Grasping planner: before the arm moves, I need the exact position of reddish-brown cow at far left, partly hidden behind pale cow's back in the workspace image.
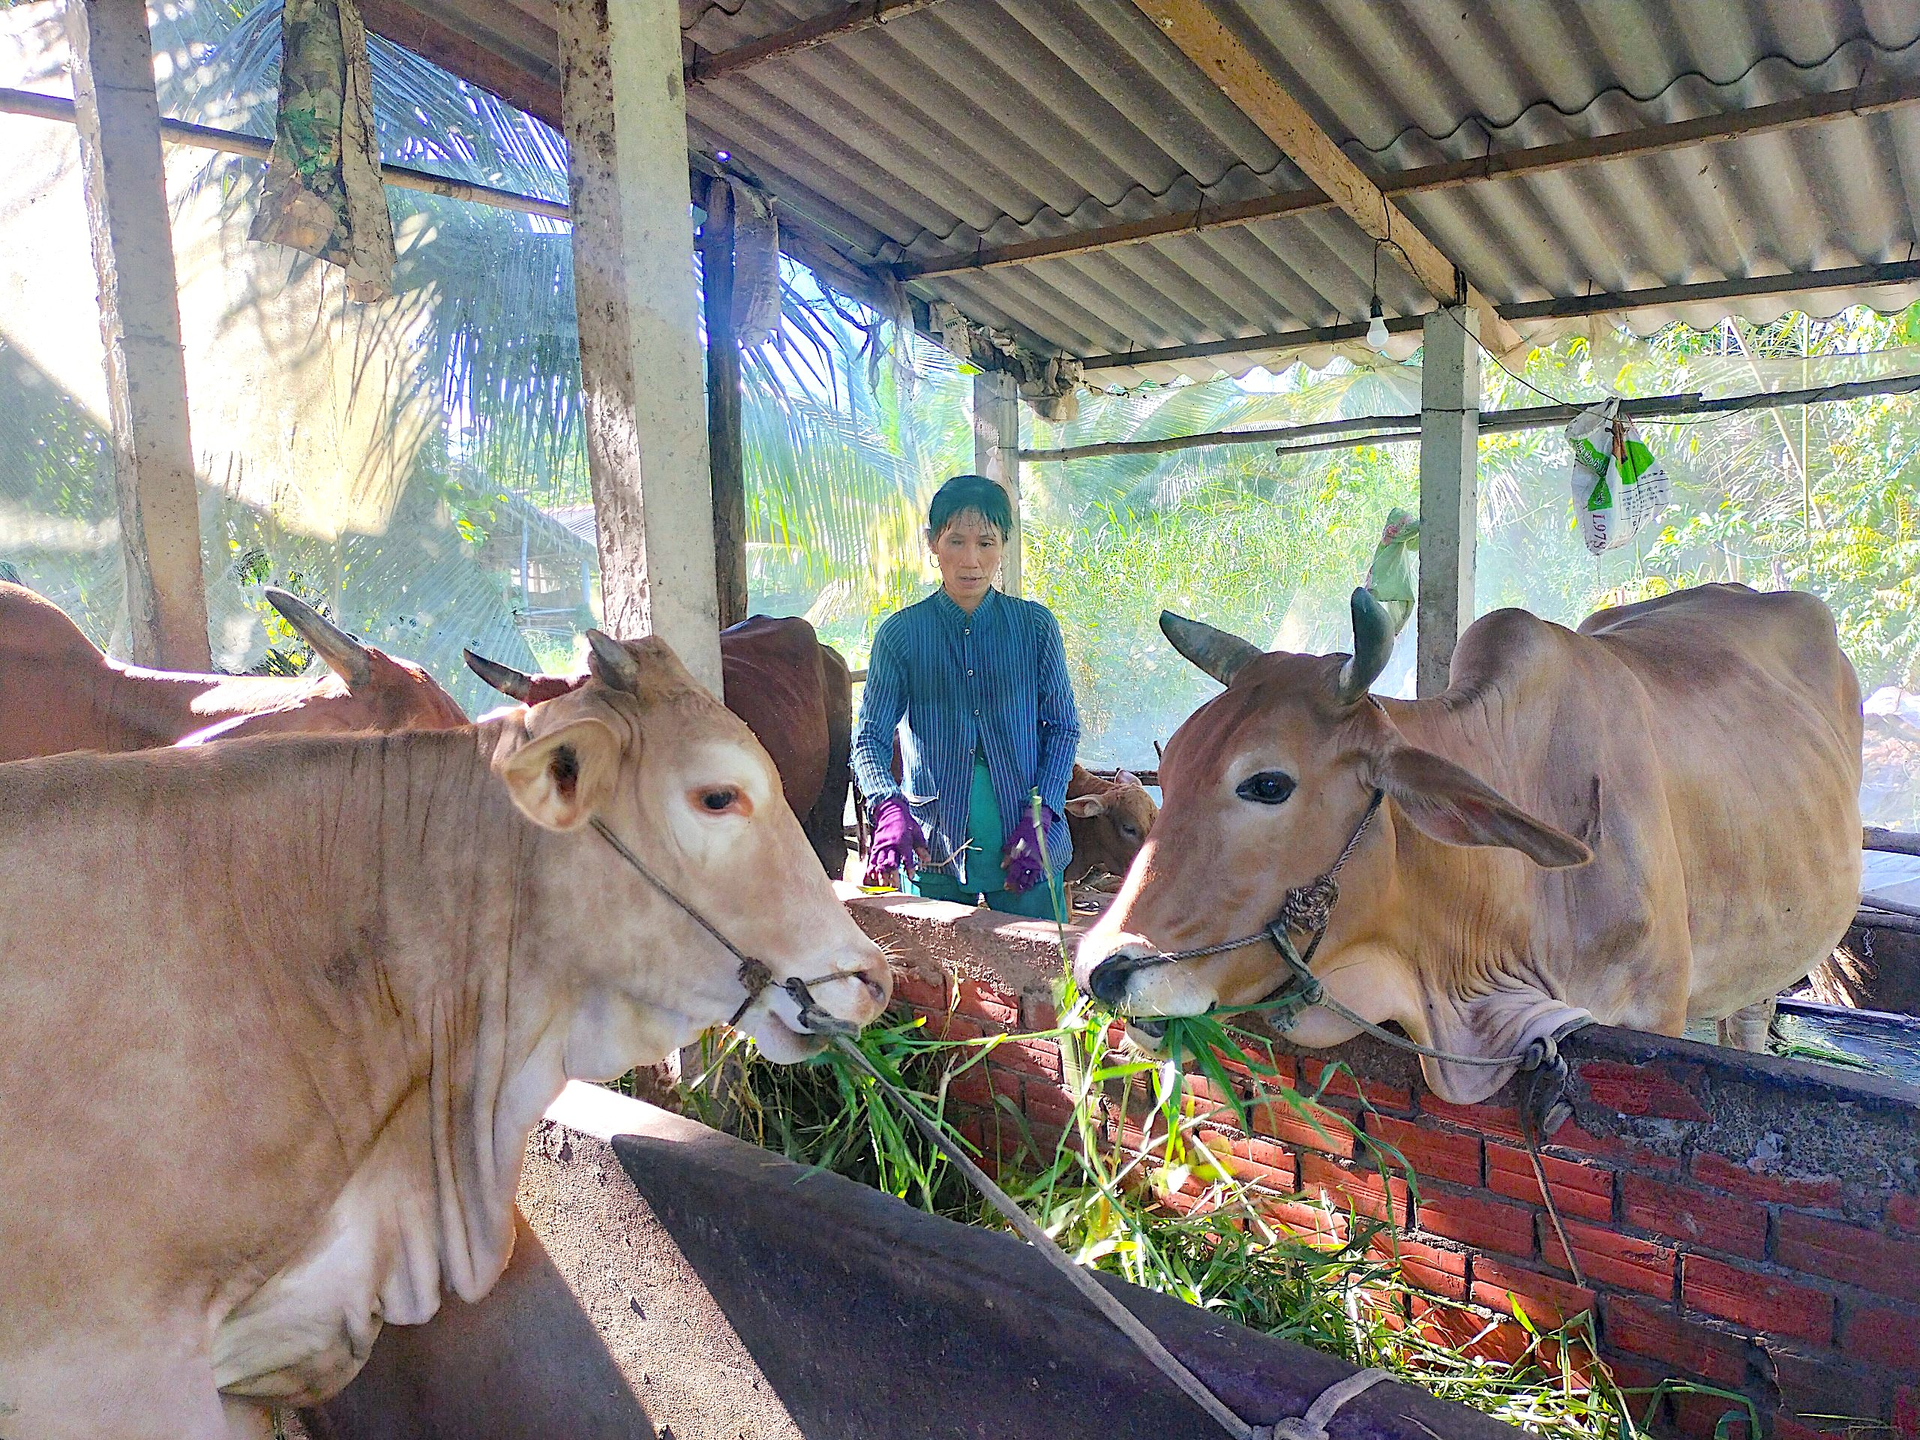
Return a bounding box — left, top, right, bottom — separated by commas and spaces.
0, 584, 467, 760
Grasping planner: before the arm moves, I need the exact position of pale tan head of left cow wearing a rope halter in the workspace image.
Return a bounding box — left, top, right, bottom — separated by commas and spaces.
493, 630, 891, 1079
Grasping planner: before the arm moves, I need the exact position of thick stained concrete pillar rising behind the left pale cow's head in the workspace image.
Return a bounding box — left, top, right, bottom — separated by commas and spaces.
559, 0, 720, 695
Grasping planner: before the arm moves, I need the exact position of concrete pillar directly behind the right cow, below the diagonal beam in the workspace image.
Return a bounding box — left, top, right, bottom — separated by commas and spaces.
1415, 309, 1480, 695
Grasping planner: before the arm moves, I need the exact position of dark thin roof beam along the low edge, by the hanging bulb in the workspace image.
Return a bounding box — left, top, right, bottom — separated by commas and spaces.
1081, 259, 1920, 371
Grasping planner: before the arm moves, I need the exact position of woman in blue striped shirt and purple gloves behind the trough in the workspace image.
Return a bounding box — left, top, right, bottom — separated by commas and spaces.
852, 474, 1079, 918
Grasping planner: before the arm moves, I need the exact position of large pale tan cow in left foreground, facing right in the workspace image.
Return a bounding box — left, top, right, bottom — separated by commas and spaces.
0, 632, 889, 1440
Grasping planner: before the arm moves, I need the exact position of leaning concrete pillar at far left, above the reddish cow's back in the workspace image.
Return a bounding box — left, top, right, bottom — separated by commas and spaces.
67, 0, 213, 670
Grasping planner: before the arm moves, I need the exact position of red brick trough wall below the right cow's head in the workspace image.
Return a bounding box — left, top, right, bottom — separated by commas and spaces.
854, 899, 1920, 1440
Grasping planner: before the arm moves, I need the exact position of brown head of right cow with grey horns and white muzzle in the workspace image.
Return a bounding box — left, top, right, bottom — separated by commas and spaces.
1075, 589, 1592, 1090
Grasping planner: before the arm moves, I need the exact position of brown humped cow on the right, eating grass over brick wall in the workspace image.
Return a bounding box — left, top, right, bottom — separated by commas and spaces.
1075, 586, 1860, 1102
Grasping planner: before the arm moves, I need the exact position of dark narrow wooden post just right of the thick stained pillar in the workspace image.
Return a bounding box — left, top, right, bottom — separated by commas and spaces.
701, 180, 747, 630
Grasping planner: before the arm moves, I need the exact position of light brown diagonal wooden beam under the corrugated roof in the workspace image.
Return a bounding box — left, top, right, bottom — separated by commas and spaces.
1133, 0, 1521, 351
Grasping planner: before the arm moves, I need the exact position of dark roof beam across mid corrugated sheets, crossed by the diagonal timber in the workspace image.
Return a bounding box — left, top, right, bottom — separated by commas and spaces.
895, 77, 1920, 280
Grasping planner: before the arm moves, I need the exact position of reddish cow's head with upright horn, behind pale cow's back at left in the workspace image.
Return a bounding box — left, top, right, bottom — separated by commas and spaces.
180, 586, 467, 745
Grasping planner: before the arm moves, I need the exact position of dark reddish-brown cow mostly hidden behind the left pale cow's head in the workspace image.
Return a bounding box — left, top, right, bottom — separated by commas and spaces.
467, 614, 852, 879
